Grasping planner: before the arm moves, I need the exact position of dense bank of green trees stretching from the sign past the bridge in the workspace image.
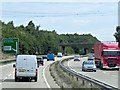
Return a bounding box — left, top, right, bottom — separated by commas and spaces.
0, 21, 98, 54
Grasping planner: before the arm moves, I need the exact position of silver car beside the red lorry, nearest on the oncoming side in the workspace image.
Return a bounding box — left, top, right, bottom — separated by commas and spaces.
82, 60, 96, 72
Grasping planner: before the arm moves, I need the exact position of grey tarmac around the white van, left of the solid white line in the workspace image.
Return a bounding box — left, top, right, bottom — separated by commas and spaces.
2, 61, 48, 88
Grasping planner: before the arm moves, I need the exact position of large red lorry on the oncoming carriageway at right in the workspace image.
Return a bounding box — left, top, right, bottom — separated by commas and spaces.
94, 43, 120, 70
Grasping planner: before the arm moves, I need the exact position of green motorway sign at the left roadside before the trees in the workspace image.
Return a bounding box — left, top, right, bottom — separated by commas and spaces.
3, 38, 19, 54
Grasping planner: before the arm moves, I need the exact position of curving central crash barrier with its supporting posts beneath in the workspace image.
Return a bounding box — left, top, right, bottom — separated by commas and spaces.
59, 57, 118, 90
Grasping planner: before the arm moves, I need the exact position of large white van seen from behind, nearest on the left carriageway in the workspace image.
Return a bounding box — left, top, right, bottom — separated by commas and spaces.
14, 55, 38, 82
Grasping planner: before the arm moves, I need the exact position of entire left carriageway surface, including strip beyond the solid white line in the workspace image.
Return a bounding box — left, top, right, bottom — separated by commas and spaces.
0, 57, 69, 90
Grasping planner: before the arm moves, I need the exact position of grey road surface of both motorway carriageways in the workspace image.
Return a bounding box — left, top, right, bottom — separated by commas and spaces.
0, 57, 120, 90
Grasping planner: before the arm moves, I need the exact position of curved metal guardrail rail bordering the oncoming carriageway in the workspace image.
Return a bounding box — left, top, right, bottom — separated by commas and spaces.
59, 58, 118, 90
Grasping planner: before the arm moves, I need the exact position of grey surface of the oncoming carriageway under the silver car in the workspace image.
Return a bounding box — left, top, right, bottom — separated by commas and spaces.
65, 57, 120, 88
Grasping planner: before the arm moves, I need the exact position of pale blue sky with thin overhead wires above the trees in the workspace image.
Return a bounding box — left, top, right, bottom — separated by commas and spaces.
0, 1, 118, 41
